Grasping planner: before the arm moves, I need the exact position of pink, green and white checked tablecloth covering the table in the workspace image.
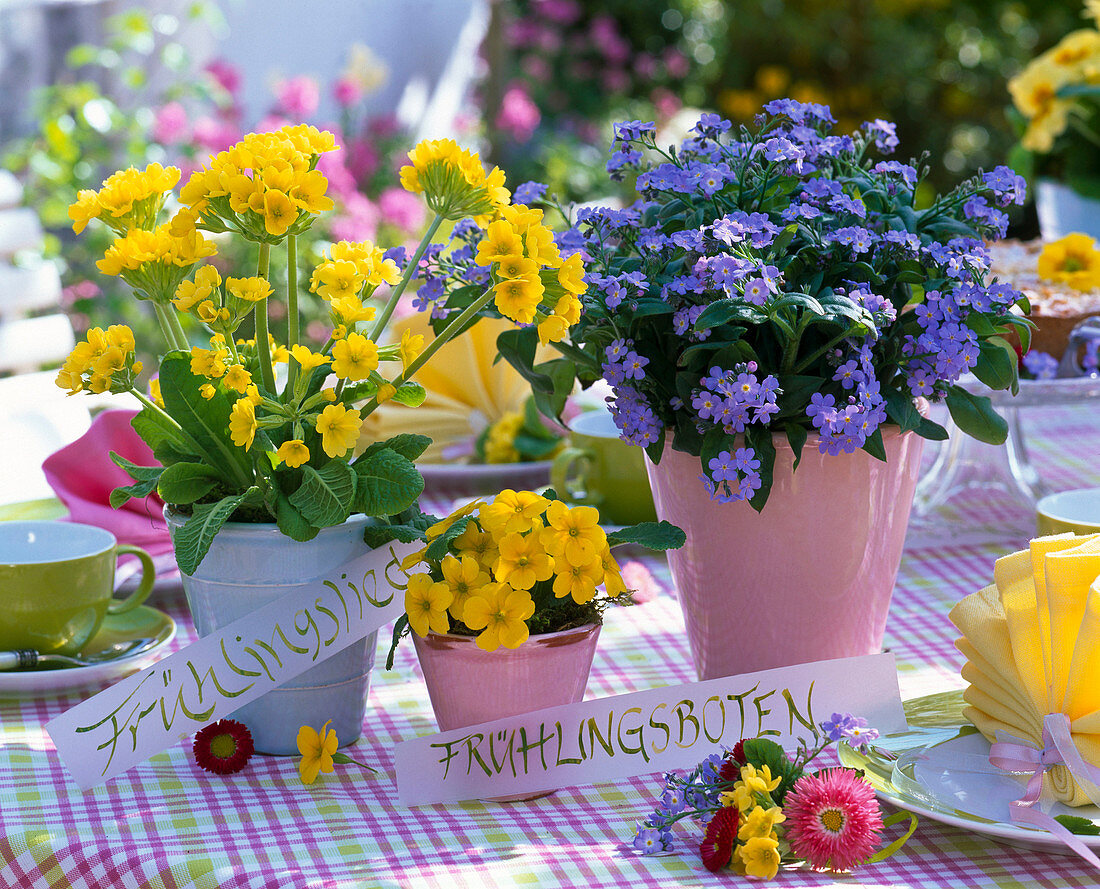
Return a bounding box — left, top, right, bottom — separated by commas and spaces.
0, 406, 1100, 889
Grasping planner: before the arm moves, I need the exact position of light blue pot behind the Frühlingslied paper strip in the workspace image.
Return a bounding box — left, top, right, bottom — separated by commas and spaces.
165, 509, 377, 755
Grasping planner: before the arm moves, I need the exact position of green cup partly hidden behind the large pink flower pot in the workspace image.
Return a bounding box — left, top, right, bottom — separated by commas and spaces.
550, 410, 657, 525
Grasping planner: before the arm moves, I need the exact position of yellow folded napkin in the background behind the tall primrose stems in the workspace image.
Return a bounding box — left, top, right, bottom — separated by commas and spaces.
360, 311, 543, 463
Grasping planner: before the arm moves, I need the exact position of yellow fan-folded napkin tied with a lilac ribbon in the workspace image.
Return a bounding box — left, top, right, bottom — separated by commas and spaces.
950, 534, 1100, 805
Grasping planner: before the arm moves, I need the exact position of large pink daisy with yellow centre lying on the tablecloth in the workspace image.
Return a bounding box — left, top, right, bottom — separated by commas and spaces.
783, 768, 882, 870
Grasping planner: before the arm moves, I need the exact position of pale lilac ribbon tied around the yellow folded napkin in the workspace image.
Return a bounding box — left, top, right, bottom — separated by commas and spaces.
989, 713, 1100, 870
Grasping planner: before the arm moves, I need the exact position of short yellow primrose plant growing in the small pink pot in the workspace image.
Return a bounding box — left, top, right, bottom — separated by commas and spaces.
387, 489, 685, 668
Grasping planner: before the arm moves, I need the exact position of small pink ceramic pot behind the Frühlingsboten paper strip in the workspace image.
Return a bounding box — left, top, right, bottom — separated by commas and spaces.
413, 624, 600, 802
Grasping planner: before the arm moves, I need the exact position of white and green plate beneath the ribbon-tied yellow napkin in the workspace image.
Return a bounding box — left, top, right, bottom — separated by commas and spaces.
838, 692, 1100, 855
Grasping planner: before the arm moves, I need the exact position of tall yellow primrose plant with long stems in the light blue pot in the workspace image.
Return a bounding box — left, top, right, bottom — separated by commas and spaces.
57, 125, 585, 574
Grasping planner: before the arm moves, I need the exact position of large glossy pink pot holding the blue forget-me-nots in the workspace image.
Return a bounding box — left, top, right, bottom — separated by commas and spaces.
647, 427, 924, 679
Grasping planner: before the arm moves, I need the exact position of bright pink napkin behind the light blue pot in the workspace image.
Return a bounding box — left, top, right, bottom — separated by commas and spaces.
42, 410, 172, 558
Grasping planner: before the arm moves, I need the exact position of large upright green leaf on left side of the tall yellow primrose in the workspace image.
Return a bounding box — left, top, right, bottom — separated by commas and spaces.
161, 352, 252, 486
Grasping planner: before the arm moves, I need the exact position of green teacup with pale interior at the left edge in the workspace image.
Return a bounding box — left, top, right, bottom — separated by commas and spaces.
0, 522, 156, 655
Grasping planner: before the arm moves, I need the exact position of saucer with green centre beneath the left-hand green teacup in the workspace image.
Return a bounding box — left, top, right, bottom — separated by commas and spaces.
0, 605, 176, 698
